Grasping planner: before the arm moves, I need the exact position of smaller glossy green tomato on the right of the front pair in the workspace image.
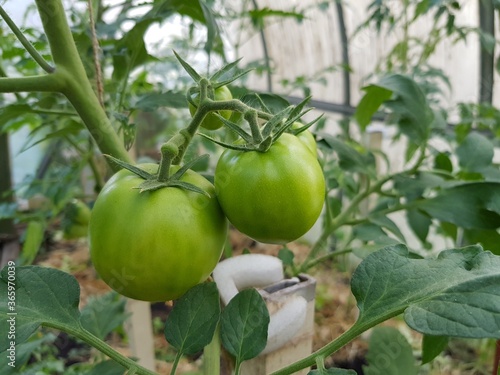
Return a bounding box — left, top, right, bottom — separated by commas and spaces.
215, 133, 325, 243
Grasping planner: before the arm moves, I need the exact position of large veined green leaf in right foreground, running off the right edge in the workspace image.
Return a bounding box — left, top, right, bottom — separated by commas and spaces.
351, 245, 500, 339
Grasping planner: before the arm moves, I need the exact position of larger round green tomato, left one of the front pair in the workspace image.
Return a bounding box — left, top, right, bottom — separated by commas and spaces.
89, 164, 227, 301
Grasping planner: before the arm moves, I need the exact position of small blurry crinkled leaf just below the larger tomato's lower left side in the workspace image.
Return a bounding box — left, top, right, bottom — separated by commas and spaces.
80, 292, 129, 340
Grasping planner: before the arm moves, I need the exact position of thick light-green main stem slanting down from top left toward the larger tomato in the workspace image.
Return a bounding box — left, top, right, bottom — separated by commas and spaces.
32, 0, 132, 170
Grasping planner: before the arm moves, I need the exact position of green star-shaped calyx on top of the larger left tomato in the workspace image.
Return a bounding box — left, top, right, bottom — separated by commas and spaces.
104, 154, 210, 197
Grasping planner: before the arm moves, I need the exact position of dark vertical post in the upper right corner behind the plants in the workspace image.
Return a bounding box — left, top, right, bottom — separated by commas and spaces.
479, 0, 495, 104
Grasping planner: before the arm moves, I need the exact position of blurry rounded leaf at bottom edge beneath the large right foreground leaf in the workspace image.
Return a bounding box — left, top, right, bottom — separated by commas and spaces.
363, 327, 418, 375
